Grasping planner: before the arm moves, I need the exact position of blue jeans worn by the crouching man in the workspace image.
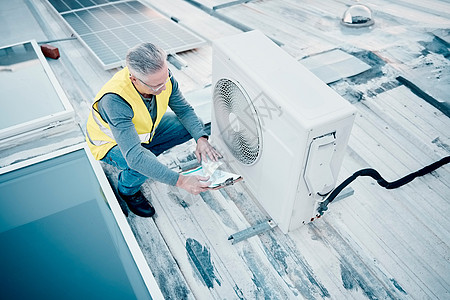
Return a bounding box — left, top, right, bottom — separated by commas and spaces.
102, 112, 192, 195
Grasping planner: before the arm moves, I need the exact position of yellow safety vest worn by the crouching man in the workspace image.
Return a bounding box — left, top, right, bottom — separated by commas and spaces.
86, 68, 172, 160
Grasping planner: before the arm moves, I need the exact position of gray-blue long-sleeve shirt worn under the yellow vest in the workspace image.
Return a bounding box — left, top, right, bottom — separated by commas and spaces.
98, 76, 207, 185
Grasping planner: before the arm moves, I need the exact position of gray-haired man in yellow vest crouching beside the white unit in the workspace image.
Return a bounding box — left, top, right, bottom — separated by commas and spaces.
86, 43, 220, 217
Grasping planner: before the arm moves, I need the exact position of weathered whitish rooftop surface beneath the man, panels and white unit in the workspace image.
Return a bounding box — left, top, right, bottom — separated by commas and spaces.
0, 0, 450, 299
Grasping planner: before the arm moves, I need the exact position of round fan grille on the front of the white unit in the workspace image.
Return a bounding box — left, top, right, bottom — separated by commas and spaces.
213, 78, 261, 165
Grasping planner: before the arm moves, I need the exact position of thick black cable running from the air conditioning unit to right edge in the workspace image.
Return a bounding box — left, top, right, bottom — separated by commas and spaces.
318, 156, 450, 215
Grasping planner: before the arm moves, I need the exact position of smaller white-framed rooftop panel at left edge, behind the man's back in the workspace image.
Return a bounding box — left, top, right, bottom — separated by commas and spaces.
0, 41, 74, 145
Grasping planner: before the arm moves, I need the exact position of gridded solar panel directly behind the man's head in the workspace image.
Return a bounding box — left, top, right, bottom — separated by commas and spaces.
48, 0, 205, 69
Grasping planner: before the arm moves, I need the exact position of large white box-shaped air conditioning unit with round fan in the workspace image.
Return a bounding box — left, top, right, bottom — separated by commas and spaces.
211, 31, 355, 233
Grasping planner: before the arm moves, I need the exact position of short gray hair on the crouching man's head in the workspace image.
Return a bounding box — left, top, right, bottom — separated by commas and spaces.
126, 43, 167, 78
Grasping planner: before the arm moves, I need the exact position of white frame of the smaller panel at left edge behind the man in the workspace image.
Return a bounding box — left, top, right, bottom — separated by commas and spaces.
0, 40, 75, 145
